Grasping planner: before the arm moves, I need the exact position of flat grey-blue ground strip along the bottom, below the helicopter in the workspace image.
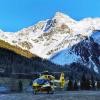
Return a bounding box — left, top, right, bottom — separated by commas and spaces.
0, 91, 100, 100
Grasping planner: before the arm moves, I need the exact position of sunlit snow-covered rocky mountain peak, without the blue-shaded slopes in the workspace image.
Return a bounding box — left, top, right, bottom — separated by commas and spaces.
0, 12, 100, 58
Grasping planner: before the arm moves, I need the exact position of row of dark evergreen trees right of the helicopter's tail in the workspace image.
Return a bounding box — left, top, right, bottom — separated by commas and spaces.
66, 74, 100, 91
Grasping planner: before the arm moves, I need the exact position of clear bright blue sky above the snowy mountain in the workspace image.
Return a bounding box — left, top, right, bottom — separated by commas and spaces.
0, 0, 100, 32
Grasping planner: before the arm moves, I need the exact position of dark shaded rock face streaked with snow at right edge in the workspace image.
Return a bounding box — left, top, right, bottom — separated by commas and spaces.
72, 32, 100, 72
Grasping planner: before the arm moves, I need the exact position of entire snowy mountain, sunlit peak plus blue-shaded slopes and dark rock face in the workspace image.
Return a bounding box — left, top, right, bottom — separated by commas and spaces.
0, 12, 100, 77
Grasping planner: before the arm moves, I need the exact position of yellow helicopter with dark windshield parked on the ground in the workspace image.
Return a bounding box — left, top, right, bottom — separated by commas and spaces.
32, 72, 65, 94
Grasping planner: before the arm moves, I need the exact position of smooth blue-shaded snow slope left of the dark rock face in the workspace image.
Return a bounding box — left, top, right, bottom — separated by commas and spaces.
50, 49, 80, 65
